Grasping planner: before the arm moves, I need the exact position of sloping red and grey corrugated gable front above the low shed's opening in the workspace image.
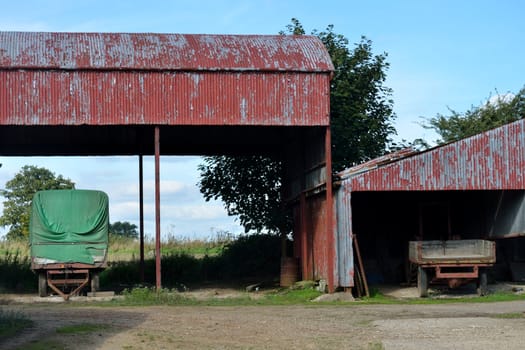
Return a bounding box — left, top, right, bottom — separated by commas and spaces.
339, 119, 525, 192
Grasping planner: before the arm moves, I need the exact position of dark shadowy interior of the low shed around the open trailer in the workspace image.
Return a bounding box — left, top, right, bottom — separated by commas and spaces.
352, 190, 525, 284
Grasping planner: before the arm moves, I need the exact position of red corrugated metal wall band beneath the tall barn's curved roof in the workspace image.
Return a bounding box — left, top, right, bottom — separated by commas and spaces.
0, 70, 329, 126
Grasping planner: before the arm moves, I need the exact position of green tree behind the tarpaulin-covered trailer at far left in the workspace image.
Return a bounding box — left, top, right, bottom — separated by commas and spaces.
0, 165, 75, 239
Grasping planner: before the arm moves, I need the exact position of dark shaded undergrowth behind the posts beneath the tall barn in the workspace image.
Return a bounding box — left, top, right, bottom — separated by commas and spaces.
100, 235, 281, 290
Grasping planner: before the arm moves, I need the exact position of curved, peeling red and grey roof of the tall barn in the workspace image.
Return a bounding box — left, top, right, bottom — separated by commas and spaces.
0, 32, 333, 72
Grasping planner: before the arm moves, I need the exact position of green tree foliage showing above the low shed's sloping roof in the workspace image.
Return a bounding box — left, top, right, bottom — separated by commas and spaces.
423, 87, 525, 144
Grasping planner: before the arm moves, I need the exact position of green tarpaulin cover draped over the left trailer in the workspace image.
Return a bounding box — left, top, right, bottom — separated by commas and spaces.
29, 190, 109, 264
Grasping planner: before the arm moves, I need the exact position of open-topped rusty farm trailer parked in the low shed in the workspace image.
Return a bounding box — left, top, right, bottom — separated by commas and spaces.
408, 239, 496, 297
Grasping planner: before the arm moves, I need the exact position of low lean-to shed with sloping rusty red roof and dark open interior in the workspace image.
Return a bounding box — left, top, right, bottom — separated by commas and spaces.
335, 120, 525, 286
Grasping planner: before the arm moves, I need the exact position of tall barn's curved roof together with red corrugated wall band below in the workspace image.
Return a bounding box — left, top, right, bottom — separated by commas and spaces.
0, 32, 333, 126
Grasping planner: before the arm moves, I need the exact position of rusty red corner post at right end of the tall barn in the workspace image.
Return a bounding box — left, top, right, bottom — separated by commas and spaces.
325, 126, 337, 293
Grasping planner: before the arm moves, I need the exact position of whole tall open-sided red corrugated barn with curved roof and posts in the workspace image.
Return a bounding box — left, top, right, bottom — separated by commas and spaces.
0, 32, 337, 290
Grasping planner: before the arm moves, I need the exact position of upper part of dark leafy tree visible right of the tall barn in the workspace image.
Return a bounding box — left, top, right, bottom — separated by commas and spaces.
318, 30, 396, 171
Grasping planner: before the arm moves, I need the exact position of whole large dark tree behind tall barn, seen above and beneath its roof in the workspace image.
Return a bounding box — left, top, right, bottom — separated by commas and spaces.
198, 19, 395, 233
